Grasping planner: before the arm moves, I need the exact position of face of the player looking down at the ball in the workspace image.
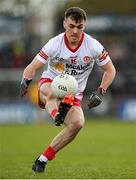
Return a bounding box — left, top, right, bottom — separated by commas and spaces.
64, 17, 85, 43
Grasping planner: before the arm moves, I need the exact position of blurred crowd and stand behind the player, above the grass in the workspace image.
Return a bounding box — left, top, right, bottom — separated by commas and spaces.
0, 0, 136, 123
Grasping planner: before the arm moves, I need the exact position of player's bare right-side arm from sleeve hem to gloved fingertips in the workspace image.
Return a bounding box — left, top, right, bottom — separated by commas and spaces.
88, 59, 116, 108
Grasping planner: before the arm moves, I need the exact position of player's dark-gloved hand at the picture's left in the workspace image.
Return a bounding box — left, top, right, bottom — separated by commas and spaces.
20, 79, 32, 97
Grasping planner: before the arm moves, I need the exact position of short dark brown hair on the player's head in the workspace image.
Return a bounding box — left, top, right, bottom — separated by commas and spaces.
65, 7, 87, 23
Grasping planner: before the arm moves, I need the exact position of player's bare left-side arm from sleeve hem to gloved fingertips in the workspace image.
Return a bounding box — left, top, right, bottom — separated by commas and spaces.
20, 58, 45, 96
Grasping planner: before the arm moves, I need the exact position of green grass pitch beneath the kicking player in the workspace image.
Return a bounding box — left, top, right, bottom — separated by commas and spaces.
0, 120, 136, 179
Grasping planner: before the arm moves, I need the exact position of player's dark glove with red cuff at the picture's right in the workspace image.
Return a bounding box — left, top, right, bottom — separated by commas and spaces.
88, 87, 106, 109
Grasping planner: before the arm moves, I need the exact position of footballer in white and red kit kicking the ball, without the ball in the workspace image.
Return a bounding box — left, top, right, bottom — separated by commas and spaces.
20, 7, 116, 172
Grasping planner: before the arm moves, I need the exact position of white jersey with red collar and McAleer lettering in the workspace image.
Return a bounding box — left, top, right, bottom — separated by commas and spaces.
36, 33, 110, 100
